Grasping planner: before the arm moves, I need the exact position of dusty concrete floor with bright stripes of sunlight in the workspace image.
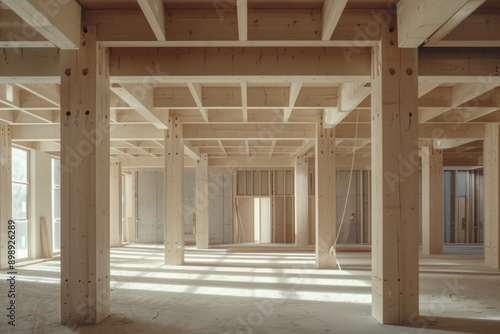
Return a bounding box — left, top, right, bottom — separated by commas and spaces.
0, 245, 500, 334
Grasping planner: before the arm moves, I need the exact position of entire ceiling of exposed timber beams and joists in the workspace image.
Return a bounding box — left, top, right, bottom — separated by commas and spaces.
0, 0, 500, 165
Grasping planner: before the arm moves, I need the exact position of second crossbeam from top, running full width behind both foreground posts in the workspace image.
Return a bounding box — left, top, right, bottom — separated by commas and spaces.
0, 47, 500, 84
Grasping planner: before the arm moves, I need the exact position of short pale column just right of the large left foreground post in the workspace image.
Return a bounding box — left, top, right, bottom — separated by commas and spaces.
109, 162, 123, 247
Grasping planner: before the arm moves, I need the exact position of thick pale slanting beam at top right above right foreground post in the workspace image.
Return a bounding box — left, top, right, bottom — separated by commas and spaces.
397, 0, 467, 48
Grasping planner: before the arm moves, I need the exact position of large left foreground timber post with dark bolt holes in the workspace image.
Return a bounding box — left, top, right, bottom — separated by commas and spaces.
61, 27, 110, 324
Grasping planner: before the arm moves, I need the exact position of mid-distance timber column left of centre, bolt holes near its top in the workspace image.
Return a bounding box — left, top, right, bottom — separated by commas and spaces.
164, 115, 184, 265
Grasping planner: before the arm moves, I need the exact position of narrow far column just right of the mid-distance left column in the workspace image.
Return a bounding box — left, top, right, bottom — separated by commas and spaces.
196, 153, 209, 249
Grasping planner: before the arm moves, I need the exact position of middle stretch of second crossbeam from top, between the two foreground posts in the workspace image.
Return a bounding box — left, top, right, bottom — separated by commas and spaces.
111, 47, 371, 82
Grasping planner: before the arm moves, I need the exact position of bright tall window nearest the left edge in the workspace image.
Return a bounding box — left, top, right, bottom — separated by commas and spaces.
12, 148, 29, 259
